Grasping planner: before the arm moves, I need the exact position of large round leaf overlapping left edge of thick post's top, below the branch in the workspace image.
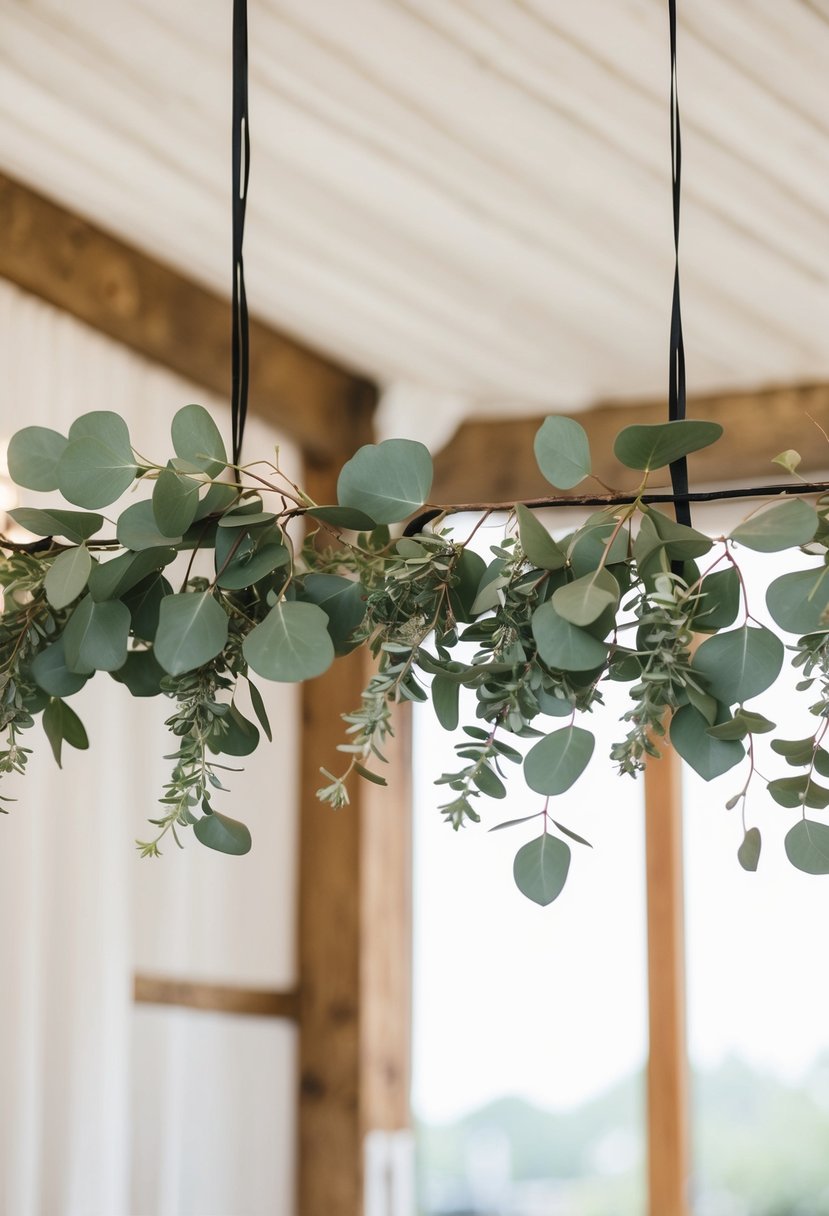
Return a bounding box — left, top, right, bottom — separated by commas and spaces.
242, 599, 334, 683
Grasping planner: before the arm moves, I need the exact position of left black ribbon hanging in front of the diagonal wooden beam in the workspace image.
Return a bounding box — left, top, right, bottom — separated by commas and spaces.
231, 0, 250, 465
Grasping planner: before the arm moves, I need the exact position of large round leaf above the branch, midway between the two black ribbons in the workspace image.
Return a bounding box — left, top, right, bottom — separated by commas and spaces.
337, 439, 433, 524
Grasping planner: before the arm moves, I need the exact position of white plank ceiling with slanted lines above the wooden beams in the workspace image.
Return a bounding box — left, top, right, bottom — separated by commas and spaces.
0, 0, 829, 437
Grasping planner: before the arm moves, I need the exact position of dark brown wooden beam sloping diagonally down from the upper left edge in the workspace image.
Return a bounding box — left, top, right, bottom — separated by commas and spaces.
0, 174, 373, 457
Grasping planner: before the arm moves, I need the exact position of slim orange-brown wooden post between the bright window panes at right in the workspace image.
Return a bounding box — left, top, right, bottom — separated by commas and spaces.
644, 748, 690, 1216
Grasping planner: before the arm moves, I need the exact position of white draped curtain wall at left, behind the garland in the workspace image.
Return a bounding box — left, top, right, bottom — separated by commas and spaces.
0, 282, 298, 1216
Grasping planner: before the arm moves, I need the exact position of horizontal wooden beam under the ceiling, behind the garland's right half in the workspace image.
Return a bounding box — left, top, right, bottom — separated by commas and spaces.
432, 384, 829, 503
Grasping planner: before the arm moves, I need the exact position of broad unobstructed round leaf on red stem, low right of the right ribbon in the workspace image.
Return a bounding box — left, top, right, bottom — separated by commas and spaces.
692, 625, 784, 705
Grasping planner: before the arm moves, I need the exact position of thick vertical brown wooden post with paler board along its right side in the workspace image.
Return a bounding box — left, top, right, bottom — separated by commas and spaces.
298, 463, 411, 1216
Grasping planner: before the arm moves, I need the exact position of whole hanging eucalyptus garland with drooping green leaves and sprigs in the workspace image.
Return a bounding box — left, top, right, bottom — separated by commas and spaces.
0, 405, 829, 903
